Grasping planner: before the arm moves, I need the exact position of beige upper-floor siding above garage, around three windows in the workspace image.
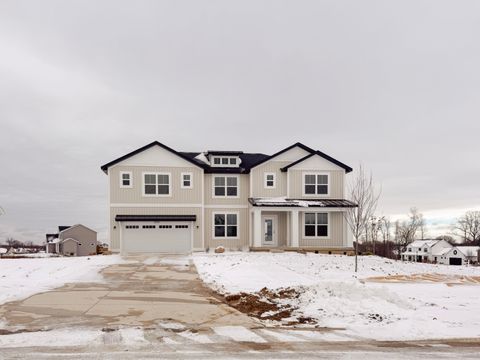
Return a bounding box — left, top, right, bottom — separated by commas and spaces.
108, 166, 203, 204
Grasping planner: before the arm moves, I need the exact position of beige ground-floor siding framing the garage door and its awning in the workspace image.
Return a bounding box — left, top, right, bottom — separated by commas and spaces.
110, 207, 203, 250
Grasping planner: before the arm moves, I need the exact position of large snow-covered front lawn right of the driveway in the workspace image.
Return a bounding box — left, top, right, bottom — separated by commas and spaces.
193, 253, 480, 340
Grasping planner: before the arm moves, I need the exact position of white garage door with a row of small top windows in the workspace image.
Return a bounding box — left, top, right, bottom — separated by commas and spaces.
122, 222, 192, 254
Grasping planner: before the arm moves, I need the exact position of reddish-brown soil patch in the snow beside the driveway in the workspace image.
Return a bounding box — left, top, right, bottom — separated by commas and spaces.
225, 288, 315, 325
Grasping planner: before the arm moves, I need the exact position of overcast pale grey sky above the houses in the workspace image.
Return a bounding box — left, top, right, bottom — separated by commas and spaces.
0, 0, 480, 242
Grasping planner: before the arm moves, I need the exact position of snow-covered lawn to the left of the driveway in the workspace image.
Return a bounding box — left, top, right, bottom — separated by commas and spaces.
0, 255, 123, 304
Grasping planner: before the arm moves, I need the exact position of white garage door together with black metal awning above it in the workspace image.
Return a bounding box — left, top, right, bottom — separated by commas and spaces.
115, 215, 196, 254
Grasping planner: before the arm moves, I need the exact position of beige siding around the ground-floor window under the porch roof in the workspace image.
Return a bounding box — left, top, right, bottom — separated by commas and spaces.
298, 210, 346, 248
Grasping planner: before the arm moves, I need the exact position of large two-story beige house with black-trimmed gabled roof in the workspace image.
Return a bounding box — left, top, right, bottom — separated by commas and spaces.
101, 141, 355, 253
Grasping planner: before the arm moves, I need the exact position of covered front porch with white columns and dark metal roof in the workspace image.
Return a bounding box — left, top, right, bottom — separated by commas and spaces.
249, 198, 354, 253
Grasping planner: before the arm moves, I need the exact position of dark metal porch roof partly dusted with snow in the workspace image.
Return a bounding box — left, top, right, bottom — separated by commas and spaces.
248, 197, 357, 208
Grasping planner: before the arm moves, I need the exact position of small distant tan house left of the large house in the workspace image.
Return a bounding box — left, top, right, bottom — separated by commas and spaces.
45, 224, 97, 256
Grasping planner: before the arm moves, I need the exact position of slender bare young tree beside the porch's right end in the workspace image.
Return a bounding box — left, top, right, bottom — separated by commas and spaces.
345, 165, 380, 272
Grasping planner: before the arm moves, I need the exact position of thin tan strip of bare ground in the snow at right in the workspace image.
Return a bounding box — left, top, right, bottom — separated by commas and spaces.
365, 273, 480, 286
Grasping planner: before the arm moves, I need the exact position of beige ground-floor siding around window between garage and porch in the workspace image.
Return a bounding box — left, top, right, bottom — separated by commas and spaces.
205, 208, 250, 249
